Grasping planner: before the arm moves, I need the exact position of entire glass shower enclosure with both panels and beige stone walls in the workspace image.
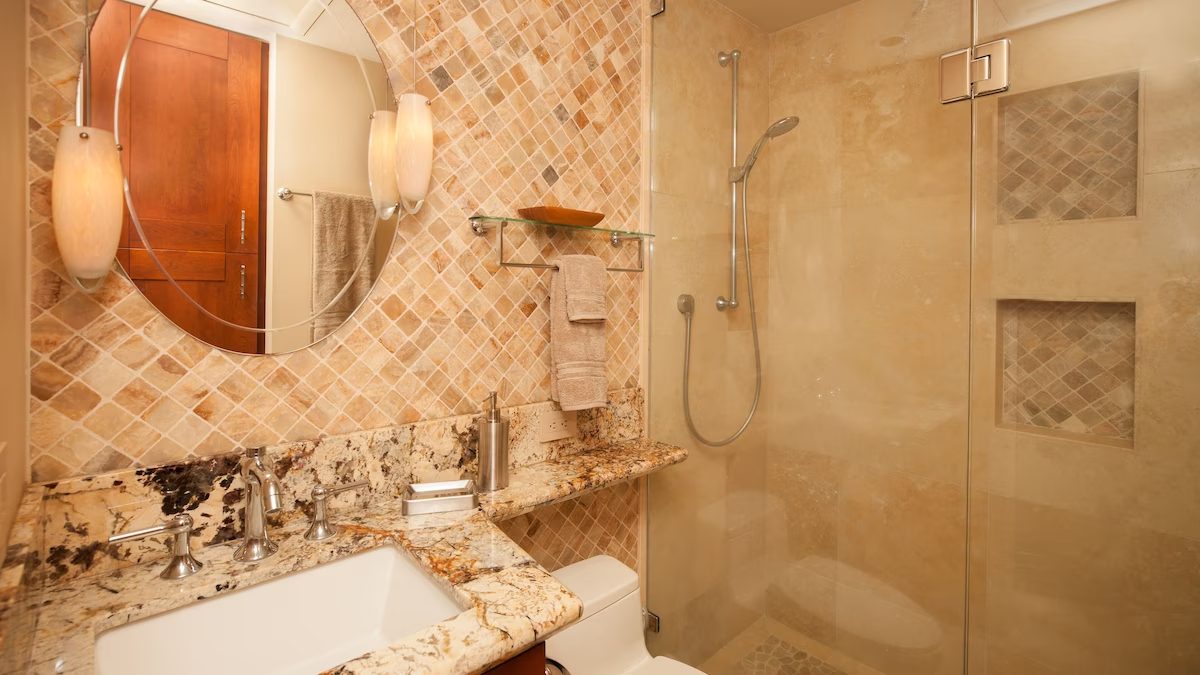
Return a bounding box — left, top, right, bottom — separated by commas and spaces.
647, 0, 1200, 675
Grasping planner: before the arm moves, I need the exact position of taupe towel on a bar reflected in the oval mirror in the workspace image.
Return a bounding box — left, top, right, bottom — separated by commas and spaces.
312, 192, 376, 340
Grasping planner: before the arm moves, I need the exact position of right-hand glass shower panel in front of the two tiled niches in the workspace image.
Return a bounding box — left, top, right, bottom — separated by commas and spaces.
970, 0, 1200, 675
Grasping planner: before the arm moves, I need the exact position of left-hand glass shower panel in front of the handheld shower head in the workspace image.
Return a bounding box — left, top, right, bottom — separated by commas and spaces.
647, 0, 971, 675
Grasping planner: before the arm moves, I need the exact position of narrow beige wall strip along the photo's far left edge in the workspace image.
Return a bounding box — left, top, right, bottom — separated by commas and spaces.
0, 0, 29, 561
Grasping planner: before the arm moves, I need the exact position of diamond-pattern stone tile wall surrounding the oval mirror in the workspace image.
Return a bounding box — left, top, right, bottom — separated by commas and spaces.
29, 0, 642, 482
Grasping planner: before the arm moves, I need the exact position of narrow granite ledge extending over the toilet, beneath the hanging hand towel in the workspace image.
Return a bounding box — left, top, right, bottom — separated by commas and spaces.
479, 438, 688, 521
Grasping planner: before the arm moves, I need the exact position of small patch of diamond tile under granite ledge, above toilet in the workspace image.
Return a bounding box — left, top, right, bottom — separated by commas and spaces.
499, 480, 641, 571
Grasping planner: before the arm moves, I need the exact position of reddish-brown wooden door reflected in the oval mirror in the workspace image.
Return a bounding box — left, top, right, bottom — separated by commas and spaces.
91, 1, 266, 352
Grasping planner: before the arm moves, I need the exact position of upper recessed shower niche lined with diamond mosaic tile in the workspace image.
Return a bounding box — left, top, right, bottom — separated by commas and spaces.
997, 72, 1140, 222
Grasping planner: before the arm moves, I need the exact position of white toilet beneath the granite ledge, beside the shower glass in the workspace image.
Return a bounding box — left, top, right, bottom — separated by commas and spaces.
546, 555, 704, 675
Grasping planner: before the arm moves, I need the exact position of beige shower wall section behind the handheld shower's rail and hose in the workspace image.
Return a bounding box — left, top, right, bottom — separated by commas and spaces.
648, 0, 772, 665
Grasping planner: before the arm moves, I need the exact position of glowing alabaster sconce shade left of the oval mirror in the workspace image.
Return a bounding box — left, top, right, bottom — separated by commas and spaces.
50, 126, 125, 291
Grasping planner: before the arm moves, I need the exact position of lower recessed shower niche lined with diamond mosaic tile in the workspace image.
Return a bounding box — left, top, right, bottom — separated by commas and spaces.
997, 300, 1136, 447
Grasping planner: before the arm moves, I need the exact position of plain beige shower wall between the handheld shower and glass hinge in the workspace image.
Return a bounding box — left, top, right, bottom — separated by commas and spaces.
766, 0, 971, 675
